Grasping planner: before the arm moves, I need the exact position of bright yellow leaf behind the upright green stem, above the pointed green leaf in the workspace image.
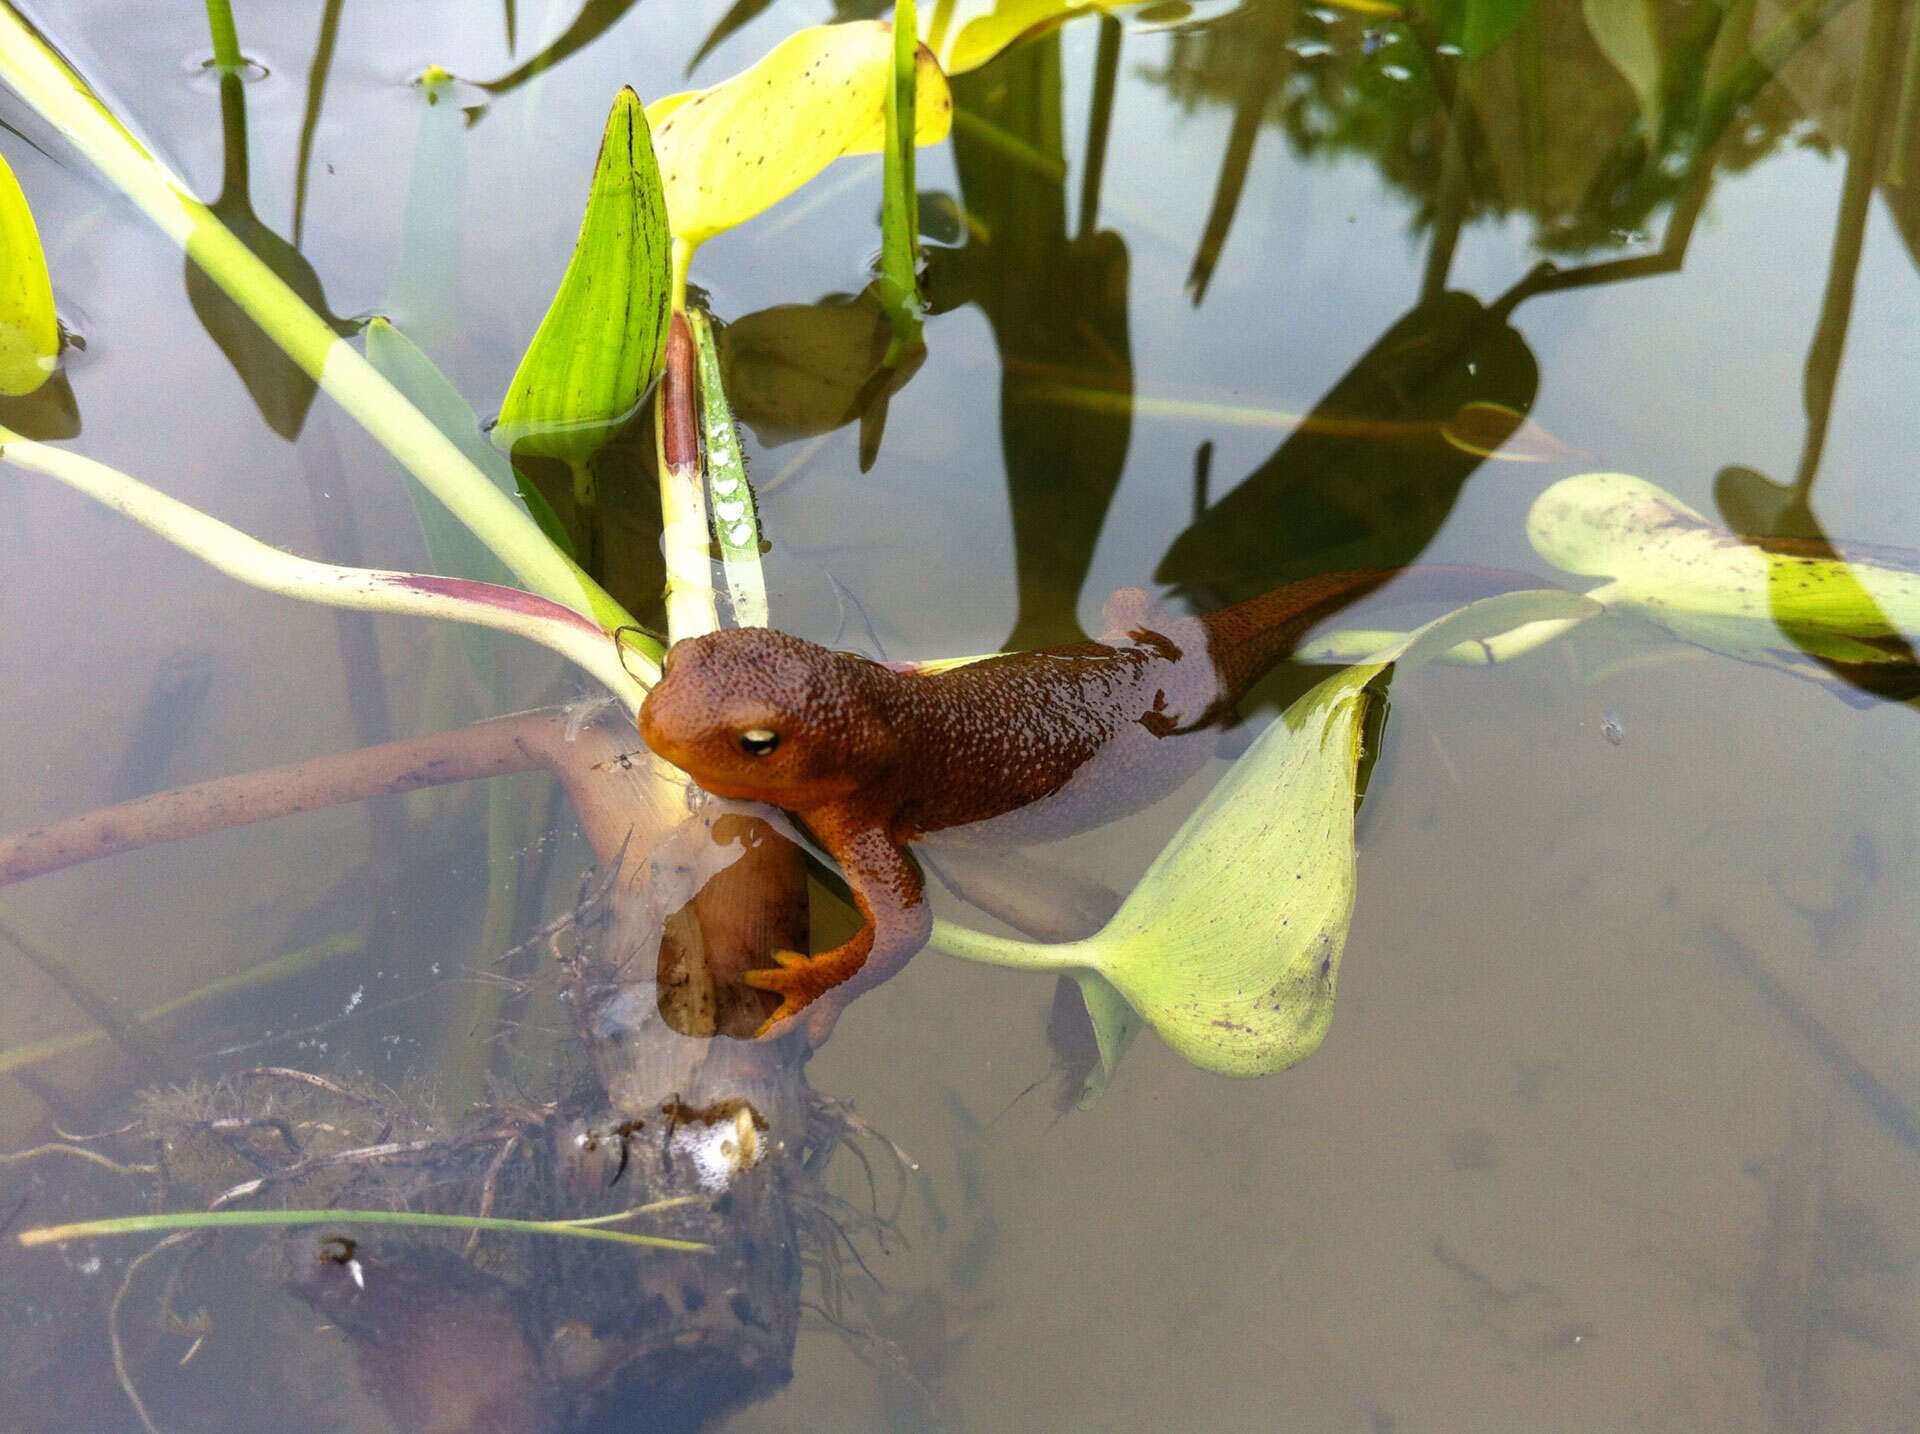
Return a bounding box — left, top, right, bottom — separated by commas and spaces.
647, 21, 952, 244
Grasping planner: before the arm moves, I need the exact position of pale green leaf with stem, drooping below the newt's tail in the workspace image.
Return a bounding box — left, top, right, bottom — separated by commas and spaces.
933, 591, 1594, 1075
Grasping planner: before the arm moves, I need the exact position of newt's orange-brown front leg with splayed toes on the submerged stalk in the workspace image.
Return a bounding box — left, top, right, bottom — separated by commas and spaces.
741, 810, 933, 1046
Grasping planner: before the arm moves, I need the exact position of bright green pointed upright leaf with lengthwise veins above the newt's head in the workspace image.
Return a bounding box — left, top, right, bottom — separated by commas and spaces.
493, 88, 672, 463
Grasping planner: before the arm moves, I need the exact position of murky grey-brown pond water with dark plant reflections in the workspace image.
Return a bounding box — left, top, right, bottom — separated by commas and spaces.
0, 0, 1920, 1432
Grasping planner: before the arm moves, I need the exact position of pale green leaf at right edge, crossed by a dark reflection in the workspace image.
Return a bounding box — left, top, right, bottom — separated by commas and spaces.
1526, 472, 1920, 662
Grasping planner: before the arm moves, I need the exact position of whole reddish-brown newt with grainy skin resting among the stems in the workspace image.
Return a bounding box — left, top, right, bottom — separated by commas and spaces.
639, 568, 1538, 1044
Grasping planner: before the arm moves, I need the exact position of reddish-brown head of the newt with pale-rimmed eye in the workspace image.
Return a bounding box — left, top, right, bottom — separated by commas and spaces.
639, 628, 895, 812
